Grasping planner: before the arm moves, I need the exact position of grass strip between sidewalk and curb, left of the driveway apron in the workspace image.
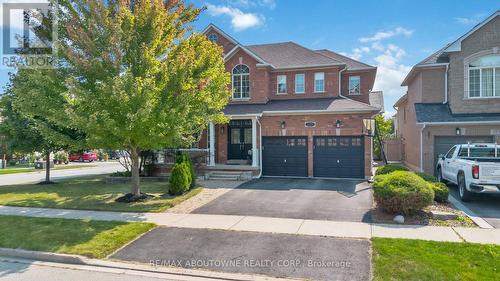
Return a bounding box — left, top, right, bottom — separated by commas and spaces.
0, 216, 155, 258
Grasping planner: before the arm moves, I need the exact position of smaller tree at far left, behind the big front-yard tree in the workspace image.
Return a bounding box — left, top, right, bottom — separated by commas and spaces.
0, 69, 85, 183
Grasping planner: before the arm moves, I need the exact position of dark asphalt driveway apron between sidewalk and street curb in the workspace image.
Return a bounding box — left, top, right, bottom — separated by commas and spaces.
111, 227, 371, 281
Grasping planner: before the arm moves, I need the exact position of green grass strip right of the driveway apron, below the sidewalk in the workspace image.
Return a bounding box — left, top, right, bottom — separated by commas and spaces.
372, 238, 500, 281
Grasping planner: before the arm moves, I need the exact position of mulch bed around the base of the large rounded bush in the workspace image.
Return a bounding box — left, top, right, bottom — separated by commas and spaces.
372, 202, 478, 227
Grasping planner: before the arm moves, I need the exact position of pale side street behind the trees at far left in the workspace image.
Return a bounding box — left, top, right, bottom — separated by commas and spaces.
0, 162, 124, 186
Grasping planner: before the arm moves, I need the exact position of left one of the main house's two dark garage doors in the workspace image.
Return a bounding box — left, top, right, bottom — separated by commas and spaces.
262, 137, 307, 177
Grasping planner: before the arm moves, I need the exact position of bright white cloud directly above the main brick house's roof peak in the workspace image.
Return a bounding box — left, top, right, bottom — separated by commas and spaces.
207, 4, 265, 31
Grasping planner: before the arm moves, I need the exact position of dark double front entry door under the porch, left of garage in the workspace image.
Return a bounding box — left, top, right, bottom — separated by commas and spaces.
228, 120, 252, 160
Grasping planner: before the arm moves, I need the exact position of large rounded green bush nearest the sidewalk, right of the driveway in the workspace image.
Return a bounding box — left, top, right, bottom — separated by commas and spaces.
373, 171, 434, 214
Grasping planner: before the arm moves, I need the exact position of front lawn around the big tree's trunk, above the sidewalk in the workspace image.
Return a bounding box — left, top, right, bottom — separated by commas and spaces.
0, 176, 201, 212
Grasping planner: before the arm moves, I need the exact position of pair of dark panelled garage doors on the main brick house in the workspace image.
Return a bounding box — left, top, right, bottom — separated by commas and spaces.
262, 136, 365, 178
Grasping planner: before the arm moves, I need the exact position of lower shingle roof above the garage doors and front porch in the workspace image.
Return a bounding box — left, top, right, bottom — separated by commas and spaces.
223, 98, 379, 115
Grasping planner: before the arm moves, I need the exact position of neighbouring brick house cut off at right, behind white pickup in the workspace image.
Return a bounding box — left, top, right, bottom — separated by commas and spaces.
394, 11, 500, 173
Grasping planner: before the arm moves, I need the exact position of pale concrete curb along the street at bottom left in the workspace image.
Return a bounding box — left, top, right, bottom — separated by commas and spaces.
0, 248, 296, 281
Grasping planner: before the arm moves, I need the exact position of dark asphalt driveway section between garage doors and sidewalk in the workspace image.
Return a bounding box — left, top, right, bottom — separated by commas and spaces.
193, 178, 373, 222
